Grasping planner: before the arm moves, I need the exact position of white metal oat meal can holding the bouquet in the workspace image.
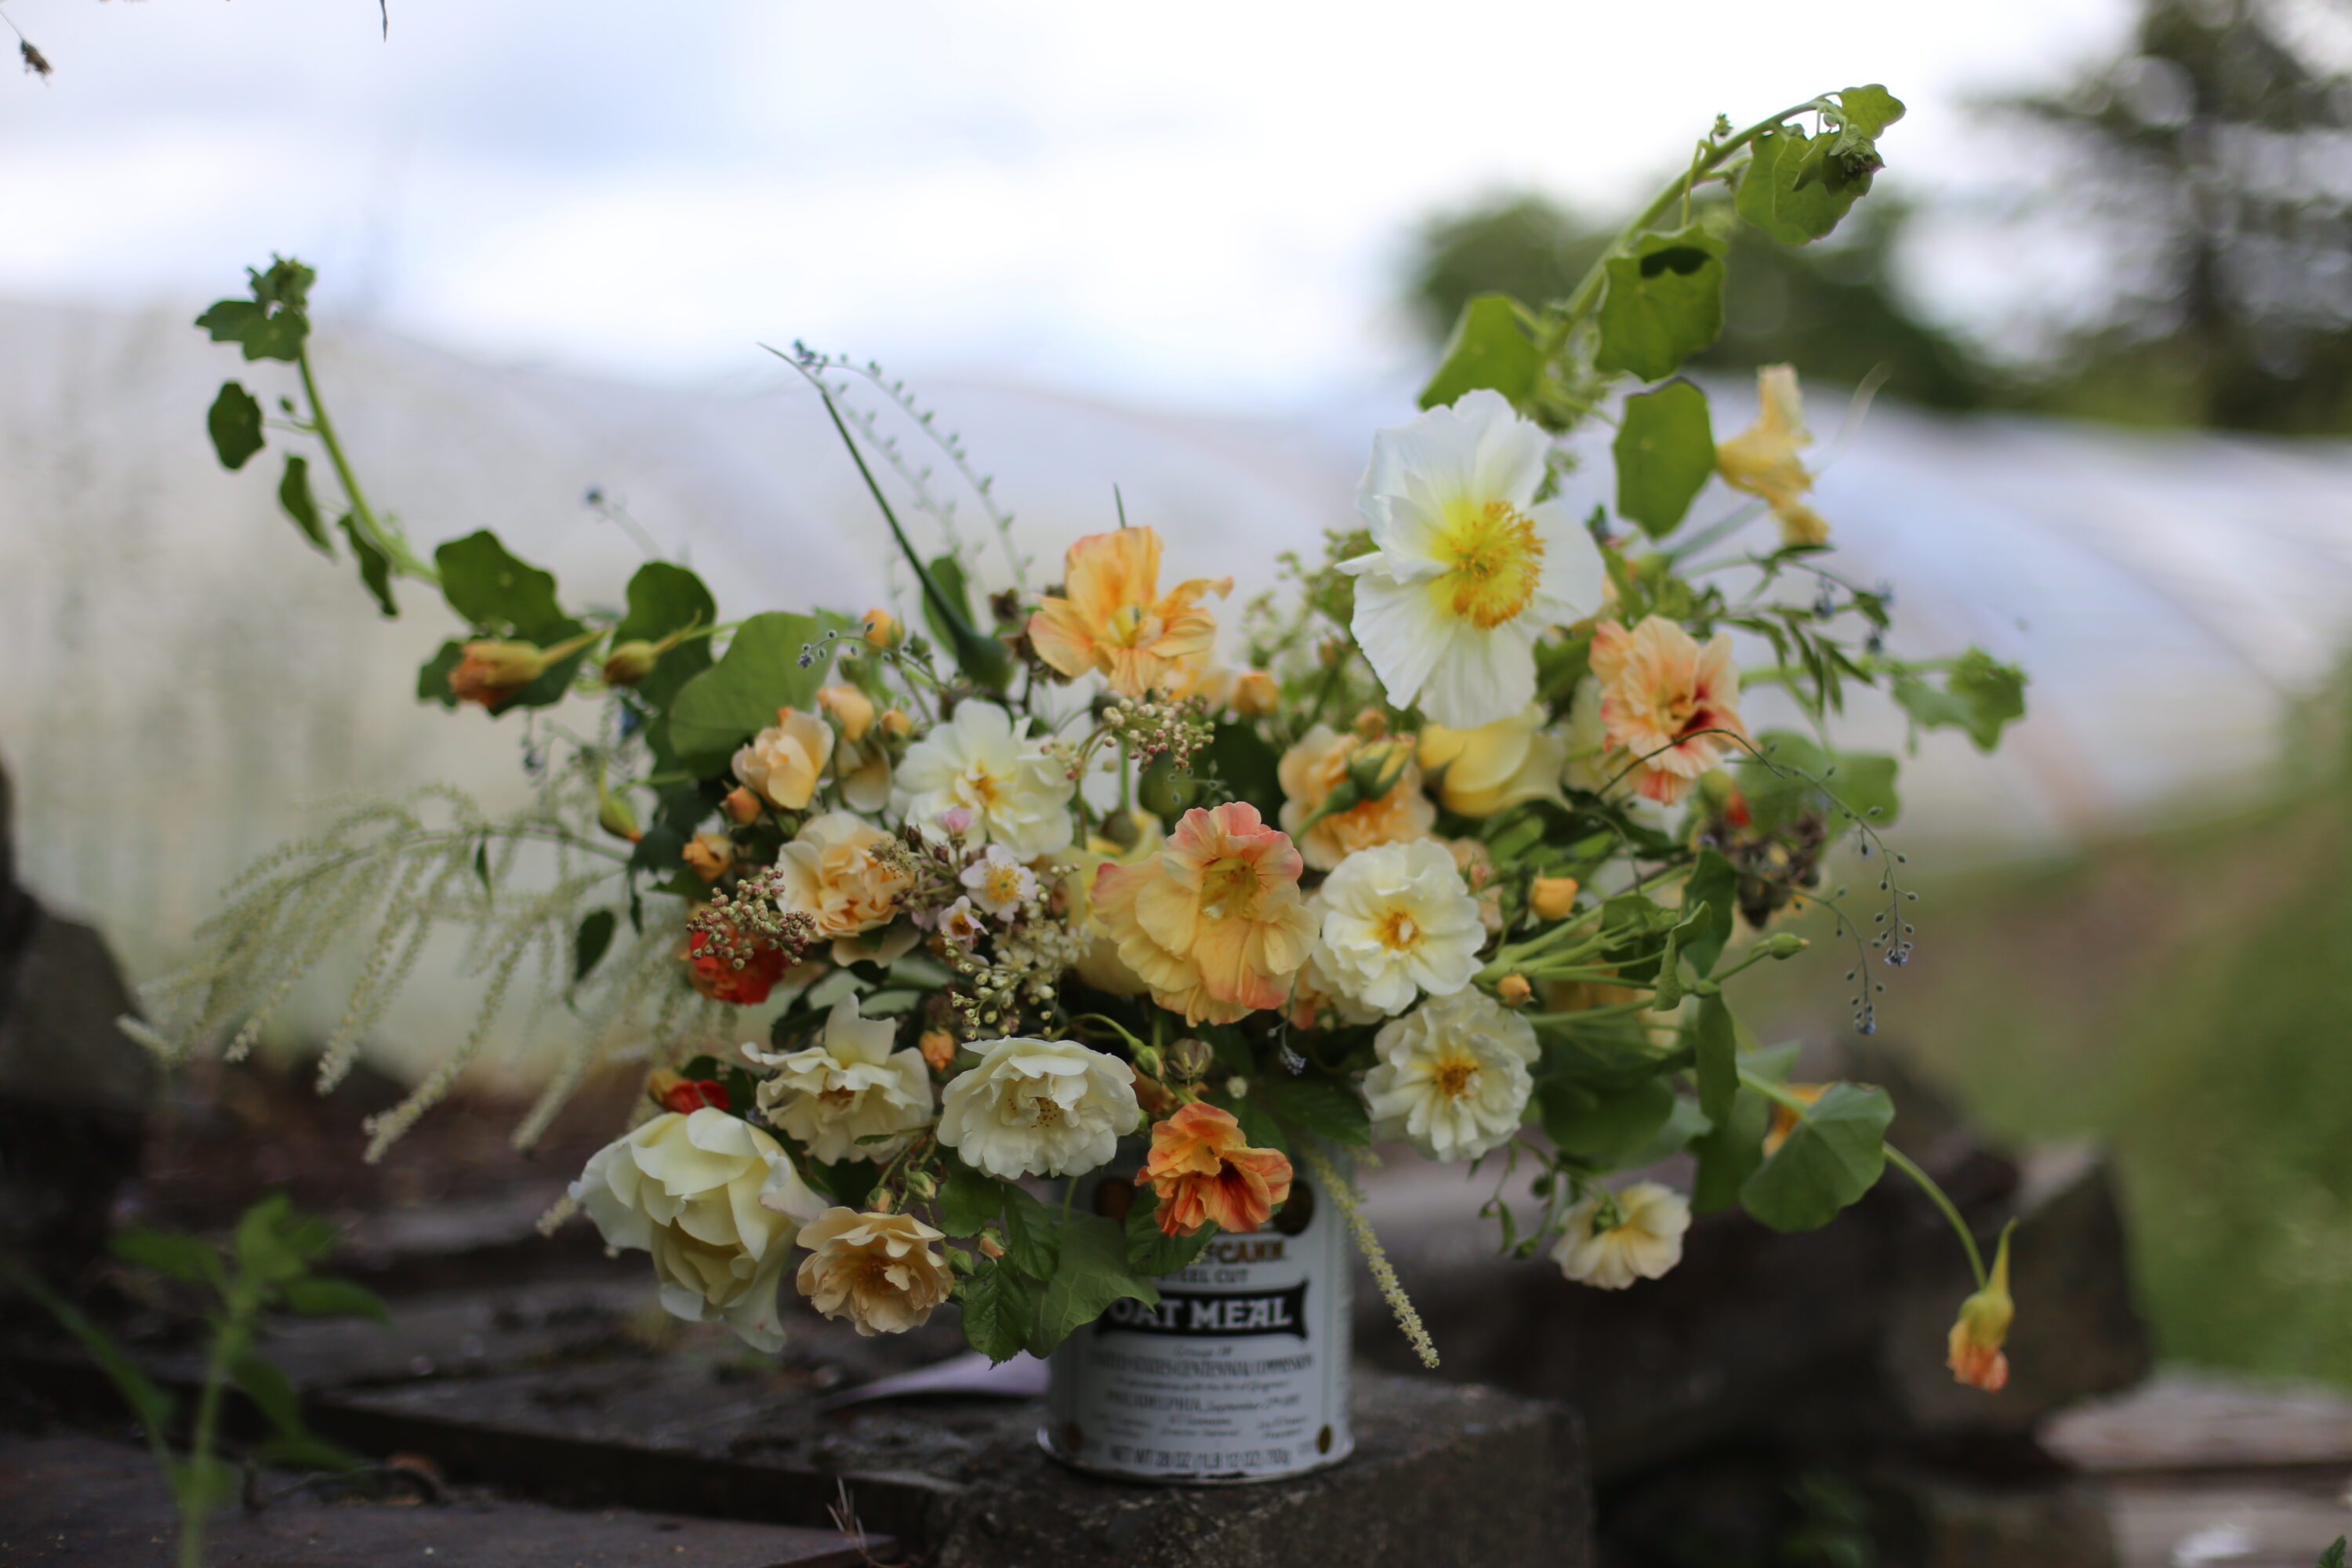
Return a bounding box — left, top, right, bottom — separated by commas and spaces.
1037, 1147, 1355, 1483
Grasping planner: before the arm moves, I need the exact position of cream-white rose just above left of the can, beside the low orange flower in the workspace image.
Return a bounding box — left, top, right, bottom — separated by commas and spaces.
938, 1039, 1143, 1180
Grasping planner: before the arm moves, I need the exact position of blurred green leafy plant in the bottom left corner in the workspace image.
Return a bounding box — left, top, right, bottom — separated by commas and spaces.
9, 1194, 388, 1568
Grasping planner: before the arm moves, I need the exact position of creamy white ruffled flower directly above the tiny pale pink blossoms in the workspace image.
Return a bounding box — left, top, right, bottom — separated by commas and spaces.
891, 701, 1077, 860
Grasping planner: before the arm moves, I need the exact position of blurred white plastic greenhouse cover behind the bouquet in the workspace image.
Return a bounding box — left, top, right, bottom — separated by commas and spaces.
0, 306, 2352, 1067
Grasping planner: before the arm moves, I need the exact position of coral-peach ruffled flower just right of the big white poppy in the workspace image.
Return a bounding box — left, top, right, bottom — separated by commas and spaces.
1592, 616, 1748, 806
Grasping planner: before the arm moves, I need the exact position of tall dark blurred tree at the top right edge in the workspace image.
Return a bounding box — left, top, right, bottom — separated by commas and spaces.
1999, 0, 2352, 433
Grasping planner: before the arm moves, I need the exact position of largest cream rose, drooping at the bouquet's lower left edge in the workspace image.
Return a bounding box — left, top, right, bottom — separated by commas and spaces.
572, 1105, 823, 1349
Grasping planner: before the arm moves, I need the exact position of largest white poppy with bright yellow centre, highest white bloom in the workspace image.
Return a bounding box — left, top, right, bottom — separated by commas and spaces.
1341, 390, 1609, 729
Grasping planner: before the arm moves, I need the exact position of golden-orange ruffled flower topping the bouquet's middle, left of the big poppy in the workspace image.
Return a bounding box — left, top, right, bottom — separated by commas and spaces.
1030, 529, 1232, 696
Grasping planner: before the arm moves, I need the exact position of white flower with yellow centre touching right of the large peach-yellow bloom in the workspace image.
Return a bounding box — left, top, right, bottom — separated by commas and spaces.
1315, 839, 1486, 1013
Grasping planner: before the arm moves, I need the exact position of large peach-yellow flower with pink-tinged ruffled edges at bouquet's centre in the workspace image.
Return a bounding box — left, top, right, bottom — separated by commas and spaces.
1094, 801, 1315, 1022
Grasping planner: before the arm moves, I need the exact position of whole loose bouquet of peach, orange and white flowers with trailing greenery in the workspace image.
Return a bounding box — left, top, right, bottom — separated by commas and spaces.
146, 87, 2023, 1387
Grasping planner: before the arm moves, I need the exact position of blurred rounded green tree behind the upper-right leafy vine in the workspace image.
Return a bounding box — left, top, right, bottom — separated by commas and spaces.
1409, 193, 1994, 409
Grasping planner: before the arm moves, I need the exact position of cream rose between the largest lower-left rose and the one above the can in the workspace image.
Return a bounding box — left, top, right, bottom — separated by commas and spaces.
743, 992, 931, 1163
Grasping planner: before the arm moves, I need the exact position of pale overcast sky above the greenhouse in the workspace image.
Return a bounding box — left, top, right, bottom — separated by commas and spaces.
0, 0, 2133, 409
